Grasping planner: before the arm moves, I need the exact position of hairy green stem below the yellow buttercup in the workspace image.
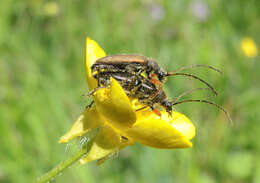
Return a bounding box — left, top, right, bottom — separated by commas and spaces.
37, 148, 89, 183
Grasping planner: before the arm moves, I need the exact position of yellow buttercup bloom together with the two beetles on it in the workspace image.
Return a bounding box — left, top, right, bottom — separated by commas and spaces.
59, 38, 232, 163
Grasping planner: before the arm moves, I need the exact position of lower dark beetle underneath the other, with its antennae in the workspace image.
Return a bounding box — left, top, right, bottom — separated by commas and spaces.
88, 72, 232, 122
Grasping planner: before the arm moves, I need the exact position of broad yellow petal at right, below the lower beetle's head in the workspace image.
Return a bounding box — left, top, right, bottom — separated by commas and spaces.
126, 110, 195, 148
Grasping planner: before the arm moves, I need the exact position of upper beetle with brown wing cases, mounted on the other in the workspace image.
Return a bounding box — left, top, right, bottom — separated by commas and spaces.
91, 54, 222, 91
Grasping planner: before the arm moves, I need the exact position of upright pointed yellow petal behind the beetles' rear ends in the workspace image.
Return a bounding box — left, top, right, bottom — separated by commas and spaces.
85, 37, 106, 90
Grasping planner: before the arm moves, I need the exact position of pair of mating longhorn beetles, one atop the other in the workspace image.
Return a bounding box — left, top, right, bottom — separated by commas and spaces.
87, 54, 230, 119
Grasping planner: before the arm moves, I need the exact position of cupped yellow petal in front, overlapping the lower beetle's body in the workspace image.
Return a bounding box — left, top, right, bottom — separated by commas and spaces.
94, 78, 136, 129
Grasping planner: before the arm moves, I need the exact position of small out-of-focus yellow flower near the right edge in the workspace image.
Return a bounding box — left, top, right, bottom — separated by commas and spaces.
240, 37, 258, 58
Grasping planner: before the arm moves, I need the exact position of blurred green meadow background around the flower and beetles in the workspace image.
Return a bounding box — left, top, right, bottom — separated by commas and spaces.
0, 0, 260, 183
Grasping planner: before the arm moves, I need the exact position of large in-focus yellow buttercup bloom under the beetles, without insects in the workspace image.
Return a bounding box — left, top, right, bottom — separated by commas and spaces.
59, 38, 195, 163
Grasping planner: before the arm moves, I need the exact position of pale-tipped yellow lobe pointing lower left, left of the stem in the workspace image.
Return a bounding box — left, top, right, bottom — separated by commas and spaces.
59, 107, 105, 143
